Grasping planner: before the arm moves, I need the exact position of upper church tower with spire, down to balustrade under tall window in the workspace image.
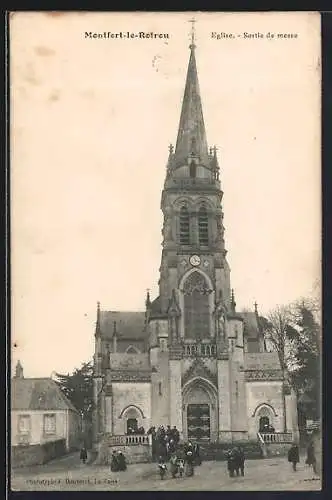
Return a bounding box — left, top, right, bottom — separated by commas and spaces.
159, 29, 231, 337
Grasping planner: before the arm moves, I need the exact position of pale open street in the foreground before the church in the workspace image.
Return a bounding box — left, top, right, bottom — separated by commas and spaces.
11, 454, 321, 491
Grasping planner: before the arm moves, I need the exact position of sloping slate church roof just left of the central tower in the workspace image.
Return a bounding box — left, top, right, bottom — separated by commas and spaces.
100, 311, 146, 339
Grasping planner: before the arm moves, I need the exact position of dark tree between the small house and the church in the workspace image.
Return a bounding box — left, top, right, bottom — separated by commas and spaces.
56, 361, 94, 422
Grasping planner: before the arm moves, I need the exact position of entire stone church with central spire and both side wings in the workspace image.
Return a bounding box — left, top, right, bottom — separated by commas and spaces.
94, 39, 297, 443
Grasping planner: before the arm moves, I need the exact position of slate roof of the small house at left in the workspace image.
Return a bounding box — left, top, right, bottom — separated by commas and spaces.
11, 378, 77, 412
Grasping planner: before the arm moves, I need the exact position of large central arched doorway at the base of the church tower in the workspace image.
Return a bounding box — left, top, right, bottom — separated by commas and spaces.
182, 378, 218, 442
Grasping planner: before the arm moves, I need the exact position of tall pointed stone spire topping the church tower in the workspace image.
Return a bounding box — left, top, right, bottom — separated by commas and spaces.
175, 21, 208, 164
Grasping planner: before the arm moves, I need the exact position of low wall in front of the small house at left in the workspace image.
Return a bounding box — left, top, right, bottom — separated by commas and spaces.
11, 439, 66, 468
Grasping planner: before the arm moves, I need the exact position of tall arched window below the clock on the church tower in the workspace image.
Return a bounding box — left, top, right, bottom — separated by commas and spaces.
184, 271, 210, 339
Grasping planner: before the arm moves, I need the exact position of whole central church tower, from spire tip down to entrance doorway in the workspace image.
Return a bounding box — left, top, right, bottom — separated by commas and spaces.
146, 24, 237, 441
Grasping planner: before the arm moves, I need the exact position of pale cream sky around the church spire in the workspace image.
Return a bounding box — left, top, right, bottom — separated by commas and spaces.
10, 12, 321, 377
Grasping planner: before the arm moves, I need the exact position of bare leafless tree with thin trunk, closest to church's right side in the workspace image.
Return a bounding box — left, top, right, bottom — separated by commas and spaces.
261, 306, 297, 432
